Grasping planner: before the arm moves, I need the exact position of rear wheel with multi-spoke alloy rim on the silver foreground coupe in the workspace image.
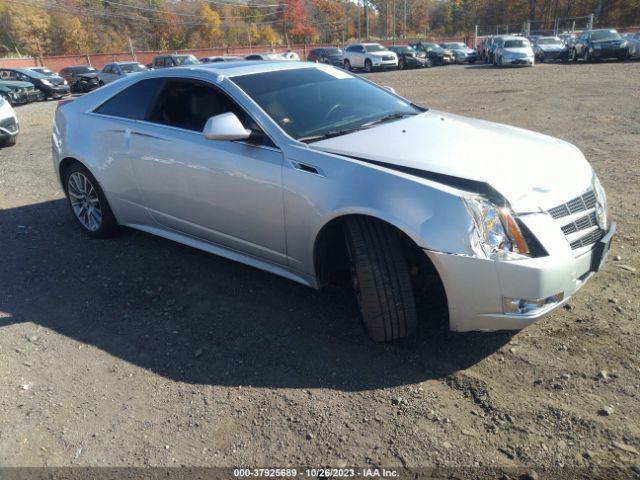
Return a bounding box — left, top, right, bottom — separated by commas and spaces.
64, 163, 118, 238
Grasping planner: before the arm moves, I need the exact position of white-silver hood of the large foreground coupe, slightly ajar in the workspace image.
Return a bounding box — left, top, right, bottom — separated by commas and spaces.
310, 110, 593, 213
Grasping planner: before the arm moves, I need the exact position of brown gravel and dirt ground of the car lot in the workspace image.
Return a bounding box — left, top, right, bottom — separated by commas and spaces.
0, 63, 640, 478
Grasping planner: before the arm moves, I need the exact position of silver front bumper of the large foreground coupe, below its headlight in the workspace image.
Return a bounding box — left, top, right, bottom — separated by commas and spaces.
425, 223, 616, 332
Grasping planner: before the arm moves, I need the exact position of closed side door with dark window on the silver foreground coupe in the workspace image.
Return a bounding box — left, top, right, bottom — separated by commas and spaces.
130, 79, 286, 264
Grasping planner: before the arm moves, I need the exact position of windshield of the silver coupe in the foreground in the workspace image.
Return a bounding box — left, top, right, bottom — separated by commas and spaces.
231, 67, 421, 141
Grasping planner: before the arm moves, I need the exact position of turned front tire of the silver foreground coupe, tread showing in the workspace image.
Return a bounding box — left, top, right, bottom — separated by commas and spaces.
346, 217, 417, 342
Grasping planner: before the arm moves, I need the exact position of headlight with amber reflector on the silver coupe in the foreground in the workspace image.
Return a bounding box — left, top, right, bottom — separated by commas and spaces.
464, 196, 529, 260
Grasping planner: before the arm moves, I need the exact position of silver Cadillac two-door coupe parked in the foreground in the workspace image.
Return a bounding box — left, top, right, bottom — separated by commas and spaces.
53, 62, 615, 341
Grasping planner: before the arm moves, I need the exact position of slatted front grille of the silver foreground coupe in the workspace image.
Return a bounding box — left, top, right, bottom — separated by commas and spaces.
548, 190, 605, 250
